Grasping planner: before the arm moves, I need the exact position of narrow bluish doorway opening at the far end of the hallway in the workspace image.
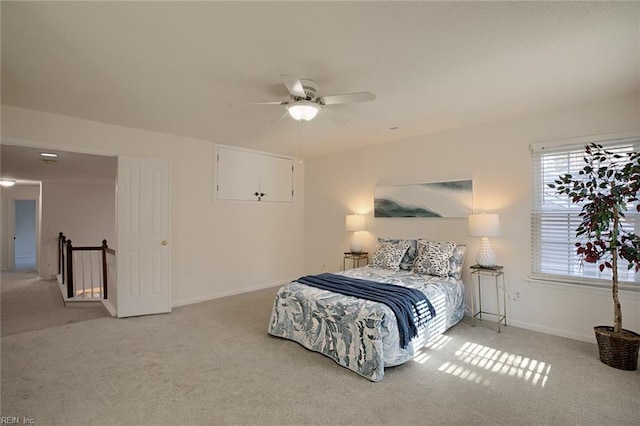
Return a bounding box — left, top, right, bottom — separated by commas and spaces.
13, 200, 36, 271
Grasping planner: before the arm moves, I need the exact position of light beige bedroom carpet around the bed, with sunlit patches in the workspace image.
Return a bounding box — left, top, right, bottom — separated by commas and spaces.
0, 272, 640, 425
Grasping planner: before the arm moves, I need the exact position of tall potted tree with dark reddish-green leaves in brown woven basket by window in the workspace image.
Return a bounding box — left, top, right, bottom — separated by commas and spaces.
549, 143, 640, 370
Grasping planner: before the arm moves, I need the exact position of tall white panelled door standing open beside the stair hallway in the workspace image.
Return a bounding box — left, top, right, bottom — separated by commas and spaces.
116, 156, 171, 317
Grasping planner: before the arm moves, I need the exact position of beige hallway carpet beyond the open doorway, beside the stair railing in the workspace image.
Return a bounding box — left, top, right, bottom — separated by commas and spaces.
0, 270, 109, 337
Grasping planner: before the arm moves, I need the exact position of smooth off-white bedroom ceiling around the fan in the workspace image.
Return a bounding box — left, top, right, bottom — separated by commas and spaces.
1, 1, 640, 160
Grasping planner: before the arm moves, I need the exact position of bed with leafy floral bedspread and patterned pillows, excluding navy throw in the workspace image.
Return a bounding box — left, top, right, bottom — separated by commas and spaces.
268, 239, 466, 382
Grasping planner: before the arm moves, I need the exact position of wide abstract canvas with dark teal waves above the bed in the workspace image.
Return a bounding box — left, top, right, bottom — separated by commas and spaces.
374, 180, 473, 218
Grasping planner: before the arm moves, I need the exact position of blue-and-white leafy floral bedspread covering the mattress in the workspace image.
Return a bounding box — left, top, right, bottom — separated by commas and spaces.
268, 266, 464, 382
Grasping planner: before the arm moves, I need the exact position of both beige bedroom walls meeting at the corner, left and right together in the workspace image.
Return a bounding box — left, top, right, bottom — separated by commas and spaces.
2, 96, 640, 340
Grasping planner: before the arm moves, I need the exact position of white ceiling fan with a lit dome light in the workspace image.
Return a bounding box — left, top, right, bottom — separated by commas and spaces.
245, 74, 376, 124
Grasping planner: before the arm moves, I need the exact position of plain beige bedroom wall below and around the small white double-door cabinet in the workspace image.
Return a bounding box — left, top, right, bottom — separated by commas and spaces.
2, 105, 304, 306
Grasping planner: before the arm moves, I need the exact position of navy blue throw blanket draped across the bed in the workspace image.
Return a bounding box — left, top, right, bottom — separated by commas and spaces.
296, 274, 436, 349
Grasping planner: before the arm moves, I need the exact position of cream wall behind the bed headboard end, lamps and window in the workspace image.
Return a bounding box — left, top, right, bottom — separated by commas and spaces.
305, 96, 640, 341
